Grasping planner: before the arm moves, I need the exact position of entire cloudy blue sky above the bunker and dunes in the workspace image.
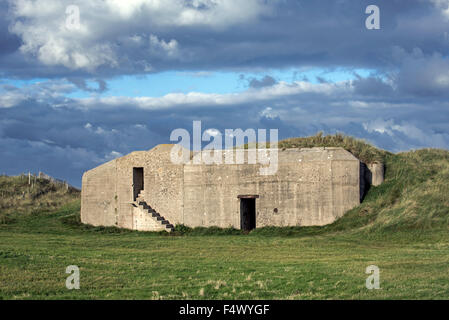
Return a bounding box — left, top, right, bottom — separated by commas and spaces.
0, 0, 449, 187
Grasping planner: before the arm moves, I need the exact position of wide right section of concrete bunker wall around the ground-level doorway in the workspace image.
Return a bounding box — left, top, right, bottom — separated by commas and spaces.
184, 148, 360, 228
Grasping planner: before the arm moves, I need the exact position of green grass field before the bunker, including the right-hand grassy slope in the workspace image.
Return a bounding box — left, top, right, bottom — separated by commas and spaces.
0, 140, 449, 299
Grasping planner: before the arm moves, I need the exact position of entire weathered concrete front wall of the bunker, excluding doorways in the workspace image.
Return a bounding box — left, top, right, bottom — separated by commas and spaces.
81, 145, 377, 231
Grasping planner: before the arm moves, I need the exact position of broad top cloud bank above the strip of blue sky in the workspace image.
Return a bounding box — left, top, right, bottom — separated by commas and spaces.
0, 0, 449, 77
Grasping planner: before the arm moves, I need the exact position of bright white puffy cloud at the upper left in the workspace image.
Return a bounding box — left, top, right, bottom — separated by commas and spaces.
9, 0, 269, 72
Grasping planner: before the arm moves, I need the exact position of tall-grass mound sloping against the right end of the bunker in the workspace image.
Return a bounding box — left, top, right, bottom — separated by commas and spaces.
252, 149, 449, 237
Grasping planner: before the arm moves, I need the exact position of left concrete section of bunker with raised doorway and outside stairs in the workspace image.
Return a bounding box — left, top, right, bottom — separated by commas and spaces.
81, 145, 183, 231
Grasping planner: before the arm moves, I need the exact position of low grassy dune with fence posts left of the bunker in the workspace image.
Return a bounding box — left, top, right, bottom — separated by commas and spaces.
0, 175, 80, 224
